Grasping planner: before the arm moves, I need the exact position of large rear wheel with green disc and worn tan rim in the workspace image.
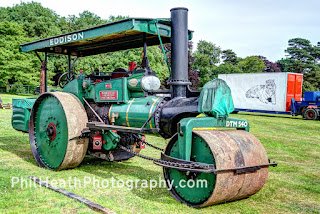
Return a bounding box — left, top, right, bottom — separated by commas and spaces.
29, 92, 88, 170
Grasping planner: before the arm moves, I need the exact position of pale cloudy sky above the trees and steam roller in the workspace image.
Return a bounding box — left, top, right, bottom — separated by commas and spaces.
0, 0, 320, 62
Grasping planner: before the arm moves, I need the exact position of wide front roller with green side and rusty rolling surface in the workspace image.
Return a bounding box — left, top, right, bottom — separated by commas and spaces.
163, 130, 268, 207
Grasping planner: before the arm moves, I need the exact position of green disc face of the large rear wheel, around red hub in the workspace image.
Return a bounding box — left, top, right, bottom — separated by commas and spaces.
35, 96, 68, 169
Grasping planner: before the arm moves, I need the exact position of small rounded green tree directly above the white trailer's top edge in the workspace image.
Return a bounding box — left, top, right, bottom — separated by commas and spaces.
239, 56, 266, 73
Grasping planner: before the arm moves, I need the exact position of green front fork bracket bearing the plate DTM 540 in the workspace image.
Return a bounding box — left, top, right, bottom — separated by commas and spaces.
178, 117, 249, 161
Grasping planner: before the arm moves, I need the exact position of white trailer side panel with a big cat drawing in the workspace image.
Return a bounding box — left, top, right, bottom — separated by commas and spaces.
218, 73, 287, 111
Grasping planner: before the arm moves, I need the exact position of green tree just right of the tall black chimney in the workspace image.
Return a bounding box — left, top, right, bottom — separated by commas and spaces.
192, 40, 221, 86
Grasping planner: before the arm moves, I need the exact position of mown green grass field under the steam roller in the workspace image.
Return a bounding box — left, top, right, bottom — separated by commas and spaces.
0, 94, 320, 213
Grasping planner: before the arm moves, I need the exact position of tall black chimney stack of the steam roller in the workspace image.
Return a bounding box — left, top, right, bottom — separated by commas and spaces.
169, 7, 191, 98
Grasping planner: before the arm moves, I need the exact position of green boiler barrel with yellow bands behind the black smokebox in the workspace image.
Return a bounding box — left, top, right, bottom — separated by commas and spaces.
109, 96, 163, 128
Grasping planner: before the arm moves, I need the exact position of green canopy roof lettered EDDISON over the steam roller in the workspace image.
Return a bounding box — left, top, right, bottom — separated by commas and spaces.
20, 18, 193, 57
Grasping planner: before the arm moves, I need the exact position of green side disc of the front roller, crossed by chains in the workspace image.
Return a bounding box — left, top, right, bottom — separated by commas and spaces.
169, 134, 216, 203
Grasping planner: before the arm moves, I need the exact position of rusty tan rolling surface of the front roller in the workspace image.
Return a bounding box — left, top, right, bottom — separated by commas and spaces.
194, 130, 268, 207
